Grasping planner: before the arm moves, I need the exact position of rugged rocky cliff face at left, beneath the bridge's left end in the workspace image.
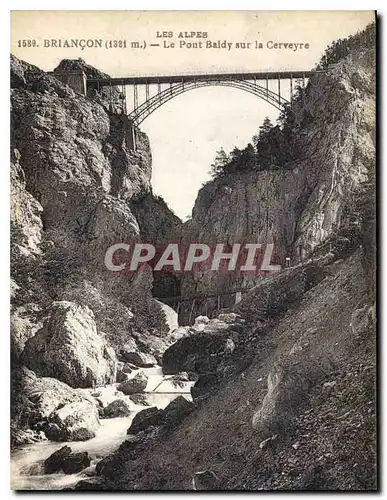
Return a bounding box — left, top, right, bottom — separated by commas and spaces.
11, 57, 179, 442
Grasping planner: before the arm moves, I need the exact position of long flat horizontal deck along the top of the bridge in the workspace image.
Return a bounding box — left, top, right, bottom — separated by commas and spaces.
87, 70, 324, 87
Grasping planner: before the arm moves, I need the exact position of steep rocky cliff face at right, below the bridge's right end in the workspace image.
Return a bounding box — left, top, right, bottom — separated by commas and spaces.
180, 49, 375, 322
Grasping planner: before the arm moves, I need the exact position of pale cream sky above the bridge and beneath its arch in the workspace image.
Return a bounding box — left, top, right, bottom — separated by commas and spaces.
11, 11, 374, 220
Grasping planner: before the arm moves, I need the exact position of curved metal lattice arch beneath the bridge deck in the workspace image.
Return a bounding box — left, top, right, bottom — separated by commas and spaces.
129, 79, 290, 126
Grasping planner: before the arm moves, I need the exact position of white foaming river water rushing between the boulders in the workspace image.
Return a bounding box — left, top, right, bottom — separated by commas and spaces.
11, 303, 194, 490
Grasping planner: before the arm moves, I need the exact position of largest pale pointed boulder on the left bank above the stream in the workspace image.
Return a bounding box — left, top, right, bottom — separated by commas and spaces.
22, 301, 116, 388
